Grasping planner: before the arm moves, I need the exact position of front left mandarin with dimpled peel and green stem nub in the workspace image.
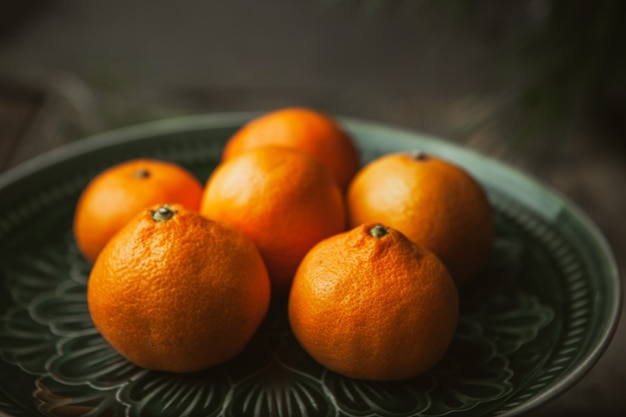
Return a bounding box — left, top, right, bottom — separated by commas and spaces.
87, 204, 270, 373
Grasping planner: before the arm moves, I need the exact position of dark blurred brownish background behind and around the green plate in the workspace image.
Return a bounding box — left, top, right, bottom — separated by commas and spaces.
0, 0, 626, 416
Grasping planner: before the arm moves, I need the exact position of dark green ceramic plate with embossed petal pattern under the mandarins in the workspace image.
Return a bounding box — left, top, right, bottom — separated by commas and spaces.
0, 114, 621, 417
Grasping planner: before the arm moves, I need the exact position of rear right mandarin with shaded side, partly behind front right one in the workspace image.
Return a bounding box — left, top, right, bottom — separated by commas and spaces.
347, 152, 494, 284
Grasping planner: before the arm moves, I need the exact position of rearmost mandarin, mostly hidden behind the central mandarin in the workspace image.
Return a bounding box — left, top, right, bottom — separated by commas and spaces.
223, 107, 359, 189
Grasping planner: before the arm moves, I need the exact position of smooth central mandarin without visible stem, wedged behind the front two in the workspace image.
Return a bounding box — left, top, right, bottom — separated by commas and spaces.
200, 146, 346, 294
